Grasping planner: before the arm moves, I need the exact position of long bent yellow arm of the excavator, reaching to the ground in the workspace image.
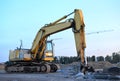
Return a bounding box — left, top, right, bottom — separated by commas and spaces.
31, 9, 86, 64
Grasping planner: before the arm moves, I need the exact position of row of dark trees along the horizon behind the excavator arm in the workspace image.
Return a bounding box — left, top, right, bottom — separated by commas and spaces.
53, 52, 120, 64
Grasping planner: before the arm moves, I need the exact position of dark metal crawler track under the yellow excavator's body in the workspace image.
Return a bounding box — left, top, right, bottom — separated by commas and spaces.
5, 62, 60, 73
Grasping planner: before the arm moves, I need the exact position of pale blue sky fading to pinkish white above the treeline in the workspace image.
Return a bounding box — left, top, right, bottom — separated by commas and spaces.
0, 0, 120, 62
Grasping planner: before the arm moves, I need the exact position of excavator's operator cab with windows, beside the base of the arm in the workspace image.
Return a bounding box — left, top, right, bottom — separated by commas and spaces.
43, 40, 54, 61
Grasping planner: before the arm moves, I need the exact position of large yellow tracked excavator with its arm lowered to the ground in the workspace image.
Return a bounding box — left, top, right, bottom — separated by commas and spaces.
5, 9, 86, 73
